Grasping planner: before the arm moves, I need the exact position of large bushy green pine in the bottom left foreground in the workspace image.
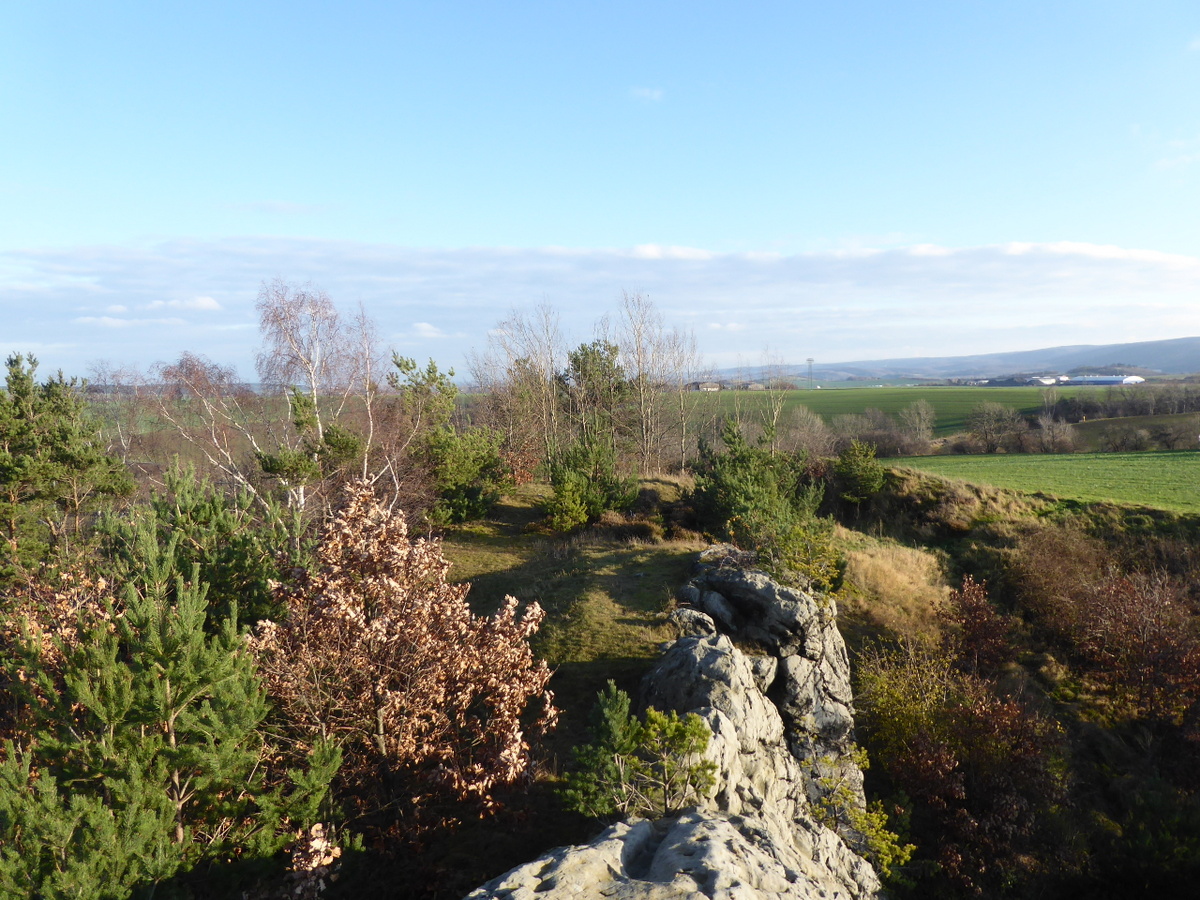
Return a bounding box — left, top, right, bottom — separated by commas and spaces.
0, 530, 340, 898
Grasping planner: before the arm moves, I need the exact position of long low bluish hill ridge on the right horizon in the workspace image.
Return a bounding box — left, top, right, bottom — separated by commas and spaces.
722, 337, 1200, 382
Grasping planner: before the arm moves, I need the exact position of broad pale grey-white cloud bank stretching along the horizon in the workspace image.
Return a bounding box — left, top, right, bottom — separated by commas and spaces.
0, 239, 1200, 376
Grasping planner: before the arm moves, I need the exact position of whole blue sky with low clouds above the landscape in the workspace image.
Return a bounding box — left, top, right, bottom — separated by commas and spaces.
0, 0, 1200, 380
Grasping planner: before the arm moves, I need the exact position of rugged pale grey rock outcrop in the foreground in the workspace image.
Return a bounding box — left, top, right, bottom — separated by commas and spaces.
468, 548, 880, 900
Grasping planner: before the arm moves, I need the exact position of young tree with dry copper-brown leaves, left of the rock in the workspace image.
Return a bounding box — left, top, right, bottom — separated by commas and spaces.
252, 482, 557, 830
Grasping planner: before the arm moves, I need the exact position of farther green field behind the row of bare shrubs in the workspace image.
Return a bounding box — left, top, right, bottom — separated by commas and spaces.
703, 385, 1109, 437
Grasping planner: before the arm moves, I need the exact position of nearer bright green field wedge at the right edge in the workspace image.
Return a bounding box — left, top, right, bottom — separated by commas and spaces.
887, 450, 1200, 514
